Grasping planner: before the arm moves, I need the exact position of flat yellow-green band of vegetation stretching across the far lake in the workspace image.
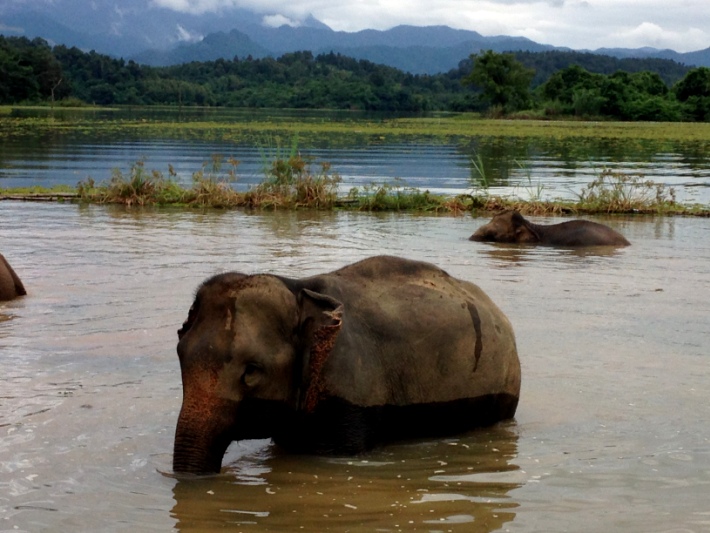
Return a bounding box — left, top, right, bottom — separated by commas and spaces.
0, 110, 710, 144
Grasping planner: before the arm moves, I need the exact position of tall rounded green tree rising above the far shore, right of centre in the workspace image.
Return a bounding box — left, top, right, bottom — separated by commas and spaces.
461, 50, 535, 113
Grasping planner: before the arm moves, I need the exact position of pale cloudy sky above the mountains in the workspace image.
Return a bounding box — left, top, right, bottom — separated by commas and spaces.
150, 0, 710, 52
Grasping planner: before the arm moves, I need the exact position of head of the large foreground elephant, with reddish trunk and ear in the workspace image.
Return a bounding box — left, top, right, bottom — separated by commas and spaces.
173, 273, 341, 473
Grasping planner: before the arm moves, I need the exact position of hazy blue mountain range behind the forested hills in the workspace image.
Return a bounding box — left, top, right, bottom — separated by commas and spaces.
0, 0, 710, 74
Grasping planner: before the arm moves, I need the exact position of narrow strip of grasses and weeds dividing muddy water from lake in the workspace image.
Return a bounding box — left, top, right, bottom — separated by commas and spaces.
6, 154, 710, 216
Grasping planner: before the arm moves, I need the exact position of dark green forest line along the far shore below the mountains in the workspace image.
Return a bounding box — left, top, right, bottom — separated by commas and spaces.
0, 36, 710, 121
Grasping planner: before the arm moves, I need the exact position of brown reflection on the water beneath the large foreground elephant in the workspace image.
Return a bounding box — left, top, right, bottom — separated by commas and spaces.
172, 425, 526, 532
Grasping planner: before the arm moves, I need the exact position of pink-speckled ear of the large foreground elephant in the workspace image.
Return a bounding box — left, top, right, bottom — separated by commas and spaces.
298, 289, 343, 413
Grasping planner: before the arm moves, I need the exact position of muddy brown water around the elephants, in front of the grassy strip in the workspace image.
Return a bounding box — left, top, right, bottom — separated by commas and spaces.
0, 202, 710, 532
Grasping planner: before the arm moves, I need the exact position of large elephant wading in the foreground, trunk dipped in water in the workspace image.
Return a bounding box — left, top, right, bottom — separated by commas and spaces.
173, 256, 521, 474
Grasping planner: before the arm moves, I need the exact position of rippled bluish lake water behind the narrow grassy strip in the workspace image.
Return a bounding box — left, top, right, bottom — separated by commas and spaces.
0, 108, 710, 206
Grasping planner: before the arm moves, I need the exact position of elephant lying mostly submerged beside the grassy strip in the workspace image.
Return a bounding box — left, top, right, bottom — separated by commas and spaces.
469, 211, 631, 247
